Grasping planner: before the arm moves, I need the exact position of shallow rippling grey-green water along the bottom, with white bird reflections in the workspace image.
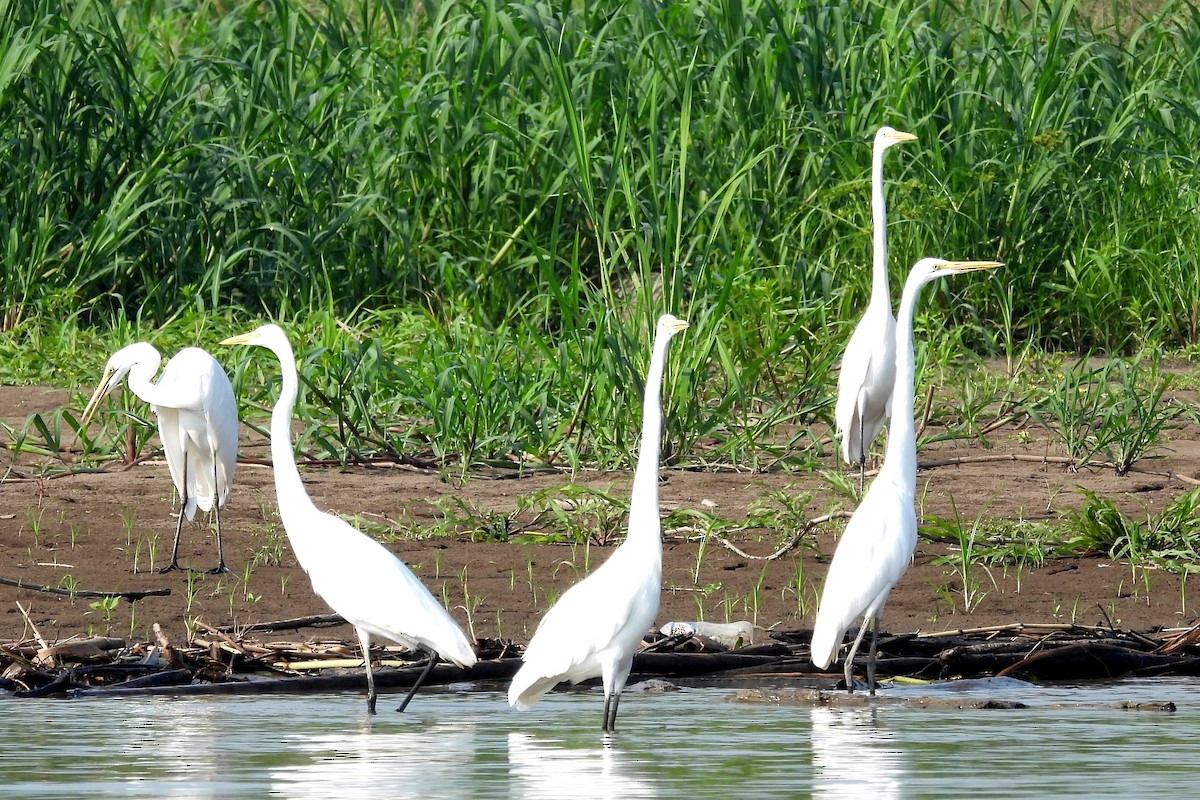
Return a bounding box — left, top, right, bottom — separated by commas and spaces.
0, 679, 1200, 800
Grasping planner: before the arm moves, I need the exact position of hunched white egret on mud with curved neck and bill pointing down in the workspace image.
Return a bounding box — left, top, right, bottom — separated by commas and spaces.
79, 342, 238, 573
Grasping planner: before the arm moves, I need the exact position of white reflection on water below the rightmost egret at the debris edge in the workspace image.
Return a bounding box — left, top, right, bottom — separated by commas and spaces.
811, 708, 908, 800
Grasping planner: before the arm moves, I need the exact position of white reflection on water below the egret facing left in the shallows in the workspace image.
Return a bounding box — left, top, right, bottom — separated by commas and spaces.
270, 720, 479, 798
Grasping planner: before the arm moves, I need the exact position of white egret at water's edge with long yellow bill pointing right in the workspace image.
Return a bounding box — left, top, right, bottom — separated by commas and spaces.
812, 258, 1000, 694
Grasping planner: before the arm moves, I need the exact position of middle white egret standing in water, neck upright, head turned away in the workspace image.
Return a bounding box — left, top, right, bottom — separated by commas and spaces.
509, 314, 688, 732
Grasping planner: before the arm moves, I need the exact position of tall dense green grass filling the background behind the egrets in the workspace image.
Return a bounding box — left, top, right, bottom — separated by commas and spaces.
0, 0, 1200, 484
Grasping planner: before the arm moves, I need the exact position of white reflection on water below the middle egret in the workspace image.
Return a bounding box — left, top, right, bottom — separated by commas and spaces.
509, 733, 656, 800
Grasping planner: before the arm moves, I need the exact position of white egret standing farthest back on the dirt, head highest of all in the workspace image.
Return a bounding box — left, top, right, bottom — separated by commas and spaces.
834, 126, 917, 488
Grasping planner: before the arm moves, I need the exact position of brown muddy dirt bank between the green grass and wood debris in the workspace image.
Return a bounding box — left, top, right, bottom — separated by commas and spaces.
0, 387, 1200, 662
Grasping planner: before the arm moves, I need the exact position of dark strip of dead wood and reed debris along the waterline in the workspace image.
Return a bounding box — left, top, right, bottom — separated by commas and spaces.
7, 618, 1200, 697
